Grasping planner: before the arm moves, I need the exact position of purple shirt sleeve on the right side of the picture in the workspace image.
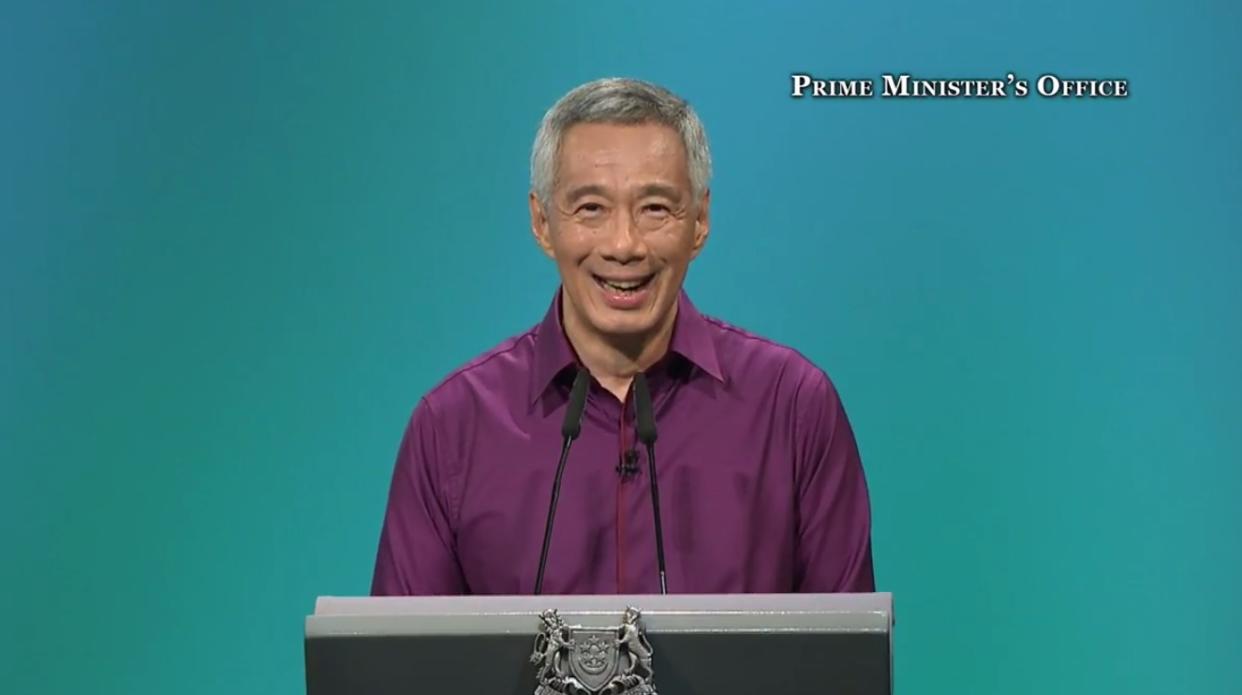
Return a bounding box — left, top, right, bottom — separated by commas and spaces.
795, 369, 876, 593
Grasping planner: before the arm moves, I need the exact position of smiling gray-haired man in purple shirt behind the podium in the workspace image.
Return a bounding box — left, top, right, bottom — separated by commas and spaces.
371, 79, 874, 594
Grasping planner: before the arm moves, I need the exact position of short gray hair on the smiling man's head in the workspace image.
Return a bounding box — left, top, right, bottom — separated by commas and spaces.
530, 77, 712, 207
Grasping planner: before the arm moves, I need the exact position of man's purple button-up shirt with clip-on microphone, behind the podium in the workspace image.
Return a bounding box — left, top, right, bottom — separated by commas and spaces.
371, 292, 874, 596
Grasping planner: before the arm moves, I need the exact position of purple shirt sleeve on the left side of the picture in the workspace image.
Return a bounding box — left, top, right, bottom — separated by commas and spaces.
371, 400, 466, 596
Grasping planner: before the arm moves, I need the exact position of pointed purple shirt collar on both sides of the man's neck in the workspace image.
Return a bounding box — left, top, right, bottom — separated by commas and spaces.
530, 288, 724, 403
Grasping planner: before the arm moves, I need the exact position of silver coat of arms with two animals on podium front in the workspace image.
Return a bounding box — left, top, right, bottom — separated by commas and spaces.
530, 608, 656, 695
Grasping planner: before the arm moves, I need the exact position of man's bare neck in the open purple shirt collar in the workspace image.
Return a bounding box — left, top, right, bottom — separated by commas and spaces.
561, 291, 677, 402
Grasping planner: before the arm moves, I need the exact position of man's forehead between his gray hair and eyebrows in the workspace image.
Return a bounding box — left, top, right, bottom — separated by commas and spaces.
556, 123, 689, 185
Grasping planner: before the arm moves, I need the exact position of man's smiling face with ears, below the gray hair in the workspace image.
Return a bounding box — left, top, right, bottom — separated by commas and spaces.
530, 123, 710, 336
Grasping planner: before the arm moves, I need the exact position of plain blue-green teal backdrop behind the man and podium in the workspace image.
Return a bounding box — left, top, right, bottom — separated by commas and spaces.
0, 1, 1242, 695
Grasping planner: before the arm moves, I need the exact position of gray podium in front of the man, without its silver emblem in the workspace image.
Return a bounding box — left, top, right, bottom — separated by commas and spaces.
306, 593, 893, 695
